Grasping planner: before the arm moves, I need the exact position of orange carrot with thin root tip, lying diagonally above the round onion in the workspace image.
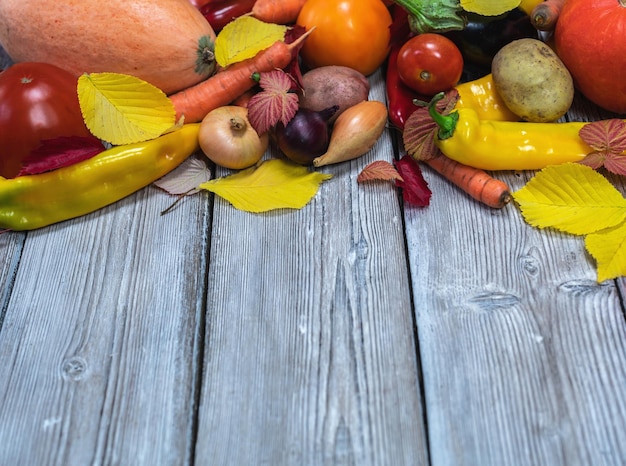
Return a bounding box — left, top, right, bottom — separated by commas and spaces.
169, 29, 313, 123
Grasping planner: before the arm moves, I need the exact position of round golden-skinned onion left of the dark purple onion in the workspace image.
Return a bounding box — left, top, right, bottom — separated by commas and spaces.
198, 105, 269, 170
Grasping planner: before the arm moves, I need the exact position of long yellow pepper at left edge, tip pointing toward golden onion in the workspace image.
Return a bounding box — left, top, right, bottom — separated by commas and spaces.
0, 124, 200, 230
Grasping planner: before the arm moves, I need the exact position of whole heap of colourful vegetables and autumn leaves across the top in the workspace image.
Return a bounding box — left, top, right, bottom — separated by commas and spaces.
0, 0, 626, 280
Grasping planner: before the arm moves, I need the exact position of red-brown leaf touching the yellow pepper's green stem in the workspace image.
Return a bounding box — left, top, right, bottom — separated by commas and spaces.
402, 89, 459, 160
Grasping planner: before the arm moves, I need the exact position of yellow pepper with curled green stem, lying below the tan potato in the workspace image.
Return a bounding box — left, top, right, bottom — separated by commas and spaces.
429, 95, 593, 170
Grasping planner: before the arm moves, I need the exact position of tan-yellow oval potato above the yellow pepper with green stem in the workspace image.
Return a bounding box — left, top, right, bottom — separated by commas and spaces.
491, 39, 574, 122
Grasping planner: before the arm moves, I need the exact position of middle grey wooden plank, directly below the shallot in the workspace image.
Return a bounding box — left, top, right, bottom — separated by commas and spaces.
196, 75, 427, 466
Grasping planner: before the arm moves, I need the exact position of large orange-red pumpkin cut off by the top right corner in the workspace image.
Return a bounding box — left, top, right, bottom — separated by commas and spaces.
554, 0, 626, 113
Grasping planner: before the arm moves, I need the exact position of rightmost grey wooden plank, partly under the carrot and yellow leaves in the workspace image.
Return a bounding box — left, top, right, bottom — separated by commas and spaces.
405, 100, 626, 466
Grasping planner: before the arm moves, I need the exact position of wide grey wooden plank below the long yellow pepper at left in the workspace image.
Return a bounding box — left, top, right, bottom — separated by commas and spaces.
0, 187, 209, 466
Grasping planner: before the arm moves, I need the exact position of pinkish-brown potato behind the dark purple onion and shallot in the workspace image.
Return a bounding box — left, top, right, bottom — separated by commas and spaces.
300, 65, 370, 123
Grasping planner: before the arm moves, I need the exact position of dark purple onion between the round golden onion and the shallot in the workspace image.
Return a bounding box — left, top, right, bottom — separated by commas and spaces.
276, 105, 339, 165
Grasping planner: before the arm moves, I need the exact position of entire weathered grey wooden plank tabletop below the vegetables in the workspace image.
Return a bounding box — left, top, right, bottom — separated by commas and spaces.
0, 44, 626, 466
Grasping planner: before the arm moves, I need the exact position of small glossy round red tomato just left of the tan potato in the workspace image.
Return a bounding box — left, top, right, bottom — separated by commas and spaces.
396, 33, 463, 96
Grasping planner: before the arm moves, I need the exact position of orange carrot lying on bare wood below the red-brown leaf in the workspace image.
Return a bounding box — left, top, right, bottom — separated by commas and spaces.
423, 154, 511, 209
